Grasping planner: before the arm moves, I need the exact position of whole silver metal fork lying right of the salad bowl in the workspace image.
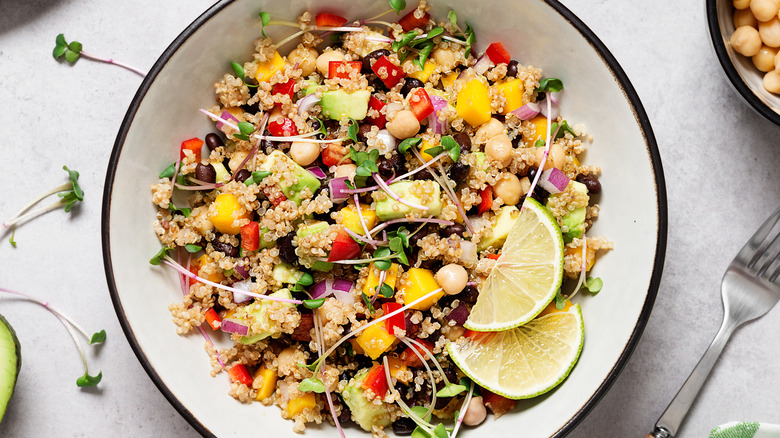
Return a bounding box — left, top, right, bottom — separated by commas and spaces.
645, 209, 780, 438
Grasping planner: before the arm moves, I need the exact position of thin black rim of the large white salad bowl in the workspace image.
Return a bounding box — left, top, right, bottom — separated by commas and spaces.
101, 0, 668, 438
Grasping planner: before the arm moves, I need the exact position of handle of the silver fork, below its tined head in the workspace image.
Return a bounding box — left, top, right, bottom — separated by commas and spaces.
645, 317, 738, 438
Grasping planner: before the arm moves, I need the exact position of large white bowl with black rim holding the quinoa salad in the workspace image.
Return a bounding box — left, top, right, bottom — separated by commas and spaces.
102, 0, 666, 438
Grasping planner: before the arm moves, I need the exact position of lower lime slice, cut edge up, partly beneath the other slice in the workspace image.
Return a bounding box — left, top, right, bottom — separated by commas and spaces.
447, 304, 585, 399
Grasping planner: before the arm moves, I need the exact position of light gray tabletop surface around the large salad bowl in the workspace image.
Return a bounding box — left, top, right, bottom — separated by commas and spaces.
0, 0, 780, 438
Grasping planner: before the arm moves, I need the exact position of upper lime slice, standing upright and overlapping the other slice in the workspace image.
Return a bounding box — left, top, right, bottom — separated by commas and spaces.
464, 199, 563, 332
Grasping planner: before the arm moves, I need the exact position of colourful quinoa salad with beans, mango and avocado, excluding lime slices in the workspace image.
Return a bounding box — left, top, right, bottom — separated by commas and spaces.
151, 0, 612, 438
